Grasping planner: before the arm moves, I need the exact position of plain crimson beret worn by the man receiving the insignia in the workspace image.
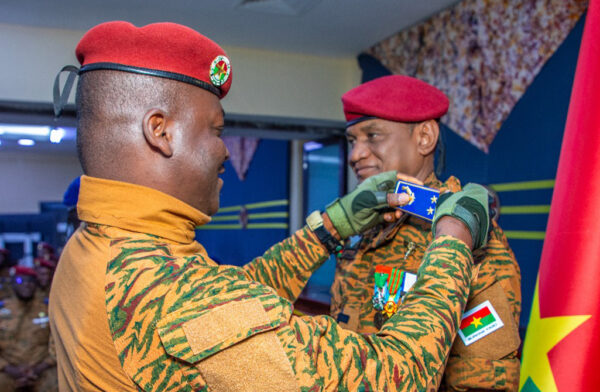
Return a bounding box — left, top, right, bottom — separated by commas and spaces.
342, 75, 449, 126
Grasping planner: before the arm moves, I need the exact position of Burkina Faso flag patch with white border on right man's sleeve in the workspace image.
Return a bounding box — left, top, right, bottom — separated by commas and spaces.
458, 301, 504, 346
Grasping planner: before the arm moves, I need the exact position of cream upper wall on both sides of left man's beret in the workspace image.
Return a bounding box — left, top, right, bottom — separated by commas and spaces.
0, 24, 360, 120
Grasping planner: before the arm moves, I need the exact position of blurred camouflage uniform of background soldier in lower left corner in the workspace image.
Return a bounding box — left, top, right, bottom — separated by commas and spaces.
0, 297, 54, 391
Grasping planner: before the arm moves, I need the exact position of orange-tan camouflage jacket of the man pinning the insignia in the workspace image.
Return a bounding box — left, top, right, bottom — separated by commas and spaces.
50, 176, 472, 391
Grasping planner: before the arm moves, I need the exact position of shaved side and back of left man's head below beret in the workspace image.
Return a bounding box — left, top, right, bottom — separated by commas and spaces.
76, 71, 180, 175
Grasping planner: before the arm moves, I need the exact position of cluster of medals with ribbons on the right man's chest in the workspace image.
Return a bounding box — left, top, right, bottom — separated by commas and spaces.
373, 265, 417, 328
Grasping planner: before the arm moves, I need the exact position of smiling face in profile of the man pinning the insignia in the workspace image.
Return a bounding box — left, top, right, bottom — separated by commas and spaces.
171, 88, 229, 215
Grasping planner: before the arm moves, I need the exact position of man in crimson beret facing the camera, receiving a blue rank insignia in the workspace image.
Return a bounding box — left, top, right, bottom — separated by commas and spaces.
331, 75, 521, 391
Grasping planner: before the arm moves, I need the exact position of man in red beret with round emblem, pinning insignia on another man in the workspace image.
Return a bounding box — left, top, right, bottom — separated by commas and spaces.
50, 22, 487, 392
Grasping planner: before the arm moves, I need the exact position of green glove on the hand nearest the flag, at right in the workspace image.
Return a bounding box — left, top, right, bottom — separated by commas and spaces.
431, 184, 490, 250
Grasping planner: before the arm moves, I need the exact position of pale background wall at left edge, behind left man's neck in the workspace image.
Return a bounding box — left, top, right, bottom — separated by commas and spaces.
0, 151, 82, 214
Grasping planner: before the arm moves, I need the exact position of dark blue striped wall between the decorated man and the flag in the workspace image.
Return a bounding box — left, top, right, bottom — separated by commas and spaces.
358, 15, 585, 330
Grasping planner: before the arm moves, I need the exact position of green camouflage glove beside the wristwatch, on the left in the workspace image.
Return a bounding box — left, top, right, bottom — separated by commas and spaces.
325, 171, 396, 239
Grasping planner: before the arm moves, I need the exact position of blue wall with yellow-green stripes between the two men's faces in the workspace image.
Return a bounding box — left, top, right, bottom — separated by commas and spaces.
196, 139, 289, 265
